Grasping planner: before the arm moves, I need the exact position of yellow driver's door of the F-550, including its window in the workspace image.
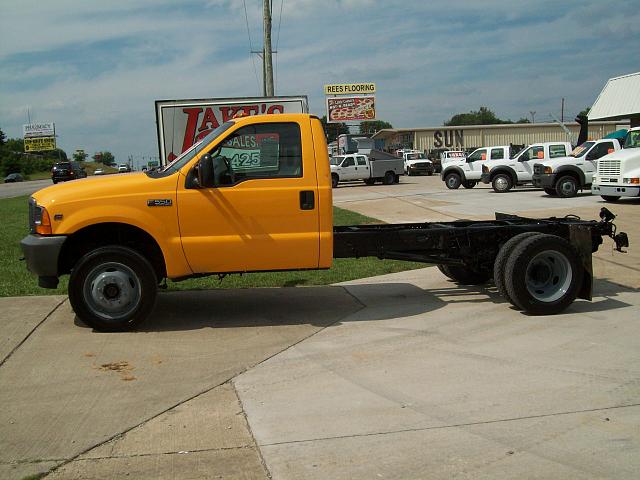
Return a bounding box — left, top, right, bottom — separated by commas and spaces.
178, 122, 320, 273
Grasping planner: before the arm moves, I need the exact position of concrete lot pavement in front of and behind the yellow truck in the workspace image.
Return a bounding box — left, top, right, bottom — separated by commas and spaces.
0, 177, 640, 479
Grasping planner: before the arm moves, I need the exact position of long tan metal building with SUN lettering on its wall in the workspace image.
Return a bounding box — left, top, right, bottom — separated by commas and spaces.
373, 122, 628, 152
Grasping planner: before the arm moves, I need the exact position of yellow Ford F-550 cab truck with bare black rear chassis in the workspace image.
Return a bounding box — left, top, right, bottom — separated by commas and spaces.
21, 114, 628, 331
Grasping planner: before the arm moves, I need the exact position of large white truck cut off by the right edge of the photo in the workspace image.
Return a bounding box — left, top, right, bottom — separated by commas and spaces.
591, 127, 640, 202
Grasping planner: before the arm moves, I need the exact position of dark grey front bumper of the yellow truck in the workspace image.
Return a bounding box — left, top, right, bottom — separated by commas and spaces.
20, 234, 67, 288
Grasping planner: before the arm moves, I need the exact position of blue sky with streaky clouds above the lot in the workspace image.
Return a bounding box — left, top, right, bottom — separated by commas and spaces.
0, 0, 640, 163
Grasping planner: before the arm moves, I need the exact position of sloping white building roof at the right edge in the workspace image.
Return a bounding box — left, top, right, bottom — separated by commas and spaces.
588, 72, 640, 121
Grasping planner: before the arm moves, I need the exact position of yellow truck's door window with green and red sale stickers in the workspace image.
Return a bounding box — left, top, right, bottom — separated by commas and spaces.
209, 123, 302, 185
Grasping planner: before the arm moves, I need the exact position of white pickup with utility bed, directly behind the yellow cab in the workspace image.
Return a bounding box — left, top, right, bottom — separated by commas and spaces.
330, 153, 404, 188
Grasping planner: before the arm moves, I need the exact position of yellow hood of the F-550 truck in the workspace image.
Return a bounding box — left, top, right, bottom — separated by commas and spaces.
32, 172, 177, 206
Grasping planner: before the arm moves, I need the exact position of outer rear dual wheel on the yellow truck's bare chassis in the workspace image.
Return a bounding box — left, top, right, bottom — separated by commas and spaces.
504, 234, 584, 315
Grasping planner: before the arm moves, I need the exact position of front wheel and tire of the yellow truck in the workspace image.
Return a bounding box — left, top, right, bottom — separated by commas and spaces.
69, 245, 158, 332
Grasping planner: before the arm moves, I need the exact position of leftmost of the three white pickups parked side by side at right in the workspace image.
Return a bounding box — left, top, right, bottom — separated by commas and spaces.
440, 145, 512, 190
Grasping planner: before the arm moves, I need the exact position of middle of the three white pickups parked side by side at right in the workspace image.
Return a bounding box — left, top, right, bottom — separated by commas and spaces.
480, 142, 572, 193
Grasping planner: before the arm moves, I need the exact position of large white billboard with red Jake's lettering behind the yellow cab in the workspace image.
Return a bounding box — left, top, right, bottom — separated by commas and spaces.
156, 96, 309, 165
